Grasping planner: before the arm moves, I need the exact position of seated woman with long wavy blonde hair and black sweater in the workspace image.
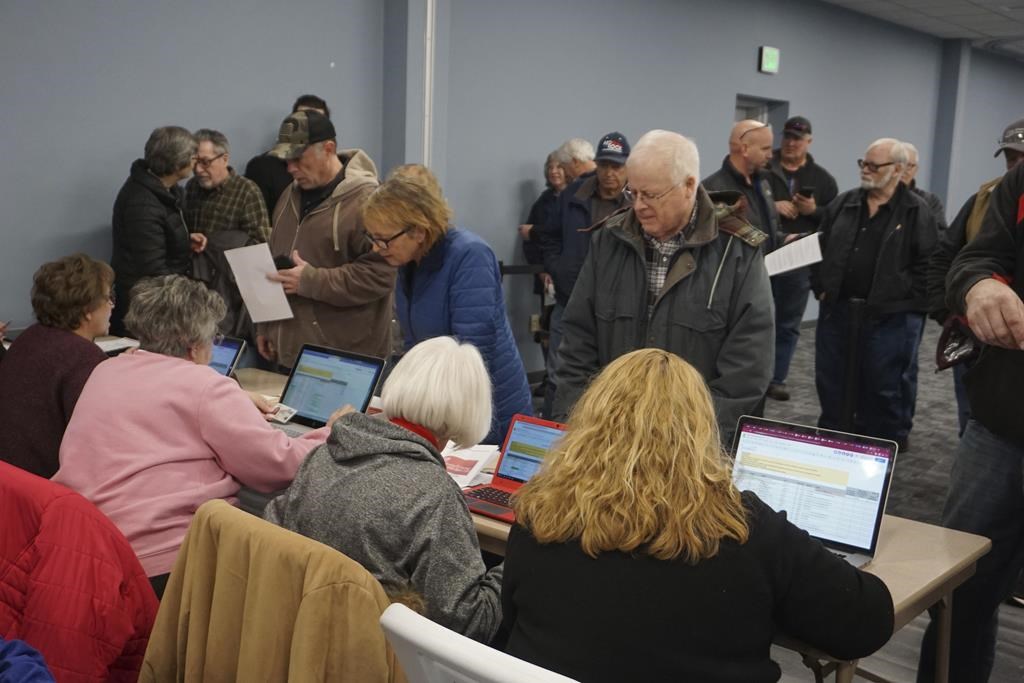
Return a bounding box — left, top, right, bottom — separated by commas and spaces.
502, 349, 893, 682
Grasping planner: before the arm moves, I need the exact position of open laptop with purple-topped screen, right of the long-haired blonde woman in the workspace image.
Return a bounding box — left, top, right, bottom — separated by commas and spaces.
732, 415, 897, 567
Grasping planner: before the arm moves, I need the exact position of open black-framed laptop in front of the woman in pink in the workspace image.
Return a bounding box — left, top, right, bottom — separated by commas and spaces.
270, 344, 384, 436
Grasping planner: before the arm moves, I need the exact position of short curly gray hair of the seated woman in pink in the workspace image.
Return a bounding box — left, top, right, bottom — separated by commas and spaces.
125, 275, 227, 358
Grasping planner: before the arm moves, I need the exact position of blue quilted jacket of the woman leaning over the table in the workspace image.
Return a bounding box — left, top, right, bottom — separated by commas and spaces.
395, 228, 534, 443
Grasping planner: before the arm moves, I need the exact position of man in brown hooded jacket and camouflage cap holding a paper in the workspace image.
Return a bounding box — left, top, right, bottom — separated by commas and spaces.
256, 111, 395, 368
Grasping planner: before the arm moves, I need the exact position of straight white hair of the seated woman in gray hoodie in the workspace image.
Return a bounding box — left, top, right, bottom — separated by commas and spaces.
381, 337, 492, 447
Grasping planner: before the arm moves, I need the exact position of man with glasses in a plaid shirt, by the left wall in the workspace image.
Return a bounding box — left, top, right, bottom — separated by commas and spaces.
184, 128, 270, 242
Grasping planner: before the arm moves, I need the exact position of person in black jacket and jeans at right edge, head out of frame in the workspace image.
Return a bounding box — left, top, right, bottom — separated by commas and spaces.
918, 158, 1024, 683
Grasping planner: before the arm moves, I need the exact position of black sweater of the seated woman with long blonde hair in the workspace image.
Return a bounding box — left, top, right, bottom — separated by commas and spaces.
502, 493, 893, 683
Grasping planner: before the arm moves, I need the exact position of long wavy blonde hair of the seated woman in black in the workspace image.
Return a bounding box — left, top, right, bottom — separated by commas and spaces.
514, 349, 749, 563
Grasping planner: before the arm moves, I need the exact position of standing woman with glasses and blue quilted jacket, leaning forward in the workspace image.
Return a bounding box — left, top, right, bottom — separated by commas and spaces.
362, 166, 532, 443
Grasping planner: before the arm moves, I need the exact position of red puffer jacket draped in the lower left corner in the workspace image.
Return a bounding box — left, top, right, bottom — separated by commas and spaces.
0, 463, 158, 683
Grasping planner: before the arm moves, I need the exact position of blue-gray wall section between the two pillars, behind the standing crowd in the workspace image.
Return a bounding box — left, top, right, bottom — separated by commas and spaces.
443, 0, 941, 368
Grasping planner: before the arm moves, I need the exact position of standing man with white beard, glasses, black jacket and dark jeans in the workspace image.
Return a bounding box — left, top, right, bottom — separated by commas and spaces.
811, 137, 938, 451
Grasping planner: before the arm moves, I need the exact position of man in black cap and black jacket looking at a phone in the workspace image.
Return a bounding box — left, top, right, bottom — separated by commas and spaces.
768, 116, 839, 400
